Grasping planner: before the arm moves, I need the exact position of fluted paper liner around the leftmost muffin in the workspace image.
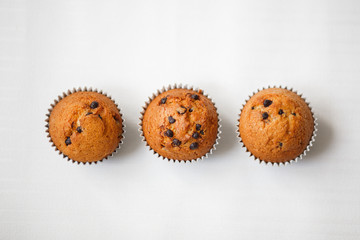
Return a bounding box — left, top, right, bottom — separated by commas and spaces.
45, 87, 126, 165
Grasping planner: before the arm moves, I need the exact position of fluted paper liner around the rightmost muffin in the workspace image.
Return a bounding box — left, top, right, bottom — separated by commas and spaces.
236, 85, 318, 166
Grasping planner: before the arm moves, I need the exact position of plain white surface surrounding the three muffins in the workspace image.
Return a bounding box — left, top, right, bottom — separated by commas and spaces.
0, 0, 360, 240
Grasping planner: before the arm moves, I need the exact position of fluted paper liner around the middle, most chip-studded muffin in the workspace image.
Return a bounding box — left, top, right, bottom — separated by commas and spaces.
139, 84, 221, 163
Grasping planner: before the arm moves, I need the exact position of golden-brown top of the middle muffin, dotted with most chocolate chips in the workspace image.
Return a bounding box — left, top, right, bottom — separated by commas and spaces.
142, 89, 218, 161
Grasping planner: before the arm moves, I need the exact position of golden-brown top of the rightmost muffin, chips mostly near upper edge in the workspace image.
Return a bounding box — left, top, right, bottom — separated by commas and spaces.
239, 88, 314, 163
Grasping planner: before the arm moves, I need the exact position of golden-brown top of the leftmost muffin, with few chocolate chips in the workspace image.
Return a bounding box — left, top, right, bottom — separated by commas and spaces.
49, 92, 123, 162
